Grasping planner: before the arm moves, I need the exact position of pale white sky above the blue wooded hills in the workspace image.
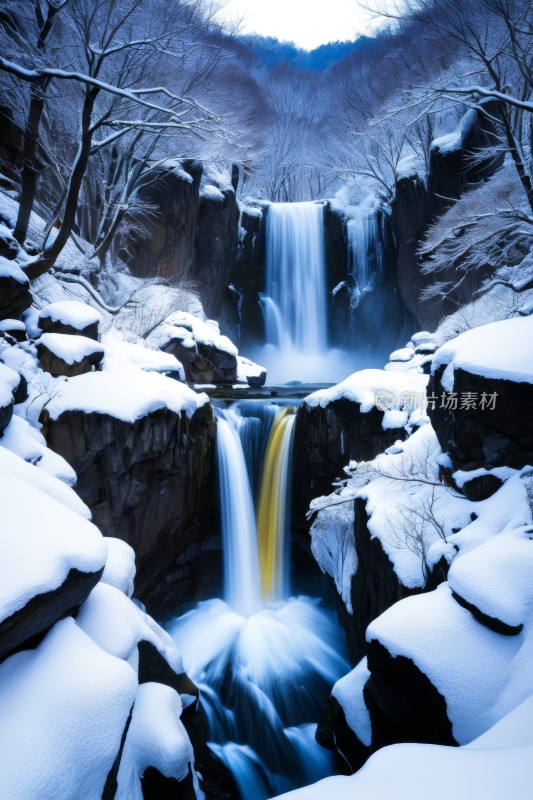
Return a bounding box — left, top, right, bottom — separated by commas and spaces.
220, 0, 378, 50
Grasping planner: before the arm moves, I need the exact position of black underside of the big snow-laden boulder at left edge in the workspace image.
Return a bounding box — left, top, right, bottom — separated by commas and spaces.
0, 569, 103, 661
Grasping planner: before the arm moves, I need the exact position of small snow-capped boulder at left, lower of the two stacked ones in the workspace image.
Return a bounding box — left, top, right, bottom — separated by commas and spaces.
37, 333, 104, 378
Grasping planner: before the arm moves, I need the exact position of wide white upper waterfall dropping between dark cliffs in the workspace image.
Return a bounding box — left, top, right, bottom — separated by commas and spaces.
264, 203, 327, 353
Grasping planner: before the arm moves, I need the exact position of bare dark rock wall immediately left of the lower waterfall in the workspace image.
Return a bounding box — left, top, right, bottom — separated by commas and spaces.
41, 406, 220, 616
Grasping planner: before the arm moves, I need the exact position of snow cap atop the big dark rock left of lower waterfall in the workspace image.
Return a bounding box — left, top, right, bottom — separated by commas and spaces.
42, 369, 209, 423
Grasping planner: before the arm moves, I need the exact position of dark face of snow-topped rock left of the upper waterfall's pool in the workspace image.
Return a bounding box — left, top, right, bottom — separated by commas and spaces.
161, 337, 237, 384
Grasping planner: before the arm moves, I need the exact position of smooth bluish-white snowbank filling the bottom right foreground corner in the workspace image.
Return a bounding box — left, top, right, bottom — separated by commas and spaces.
274, 697, 533, 800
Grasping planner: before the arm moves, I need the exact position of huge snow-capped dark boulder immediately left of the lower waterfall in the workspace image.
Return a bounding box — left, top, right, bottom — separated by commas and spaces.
37, 364, 215, 610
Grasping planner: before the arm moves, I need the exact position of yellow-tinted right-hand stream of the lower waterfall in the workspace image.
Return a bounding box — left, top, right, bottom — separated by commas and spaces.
257, 408, 296, 600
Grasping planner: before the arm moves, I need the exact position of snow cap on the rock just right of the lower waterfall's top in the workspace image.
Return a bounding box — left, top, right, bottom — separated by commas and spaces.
304, 369, 428, 414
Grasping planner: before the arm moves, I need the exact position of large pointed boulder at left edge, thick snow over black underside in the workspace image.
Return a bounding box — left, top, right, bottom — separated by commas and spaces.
0, 462, 107, 658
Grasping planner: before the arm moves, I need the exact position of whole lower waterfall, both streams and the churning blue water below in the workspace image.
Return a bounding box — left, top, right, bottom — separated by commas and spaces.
168, 401, 349, 800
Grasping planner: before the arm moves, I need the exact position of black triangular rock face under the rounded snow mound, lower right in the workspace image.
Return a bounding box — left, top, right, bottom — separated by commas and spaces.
364, 640, 457, 752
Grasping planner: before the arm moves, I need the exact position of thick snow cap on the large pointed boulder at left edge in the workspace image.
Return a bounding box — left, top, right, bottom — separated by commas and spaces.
0, 472, 107, 620
